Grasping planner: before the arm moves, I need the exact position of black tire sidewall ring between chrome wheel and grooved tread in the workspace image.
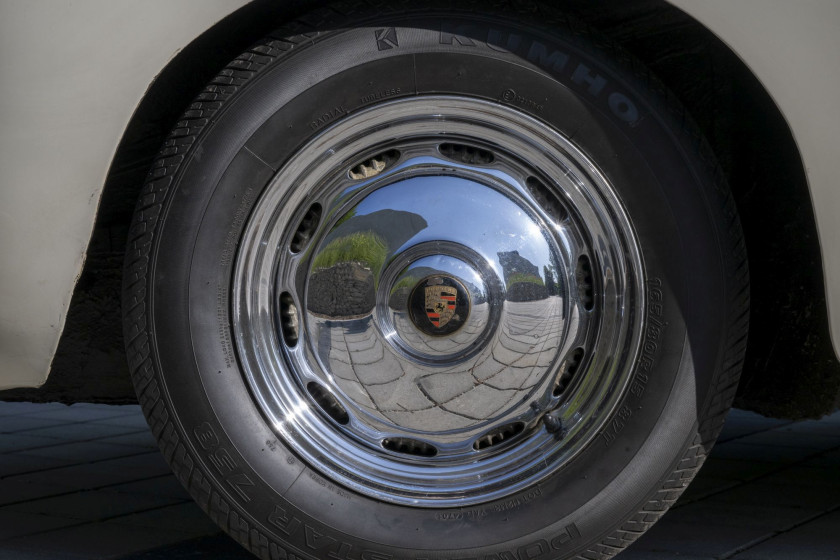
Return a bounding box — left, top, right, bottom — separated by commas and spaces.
150, 18, 725, 560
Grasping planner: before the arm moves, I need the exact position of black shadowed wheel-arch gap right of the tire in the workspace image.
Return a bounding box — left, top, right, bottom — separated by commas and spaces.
564, 0, 840, 418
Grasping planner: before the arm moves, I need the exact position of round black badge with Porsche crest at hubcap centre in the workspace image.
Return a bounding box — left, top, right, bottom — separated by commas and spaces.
408, 276, 470, 336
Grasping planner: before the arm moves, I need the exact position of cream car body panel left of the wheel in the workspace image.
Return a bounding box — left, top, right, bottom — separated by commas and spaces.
0, 0, 246, 389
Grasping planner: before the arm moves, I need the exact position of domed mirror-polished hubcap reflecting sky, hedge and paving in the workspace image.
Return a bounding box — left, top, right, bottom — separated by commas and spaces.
307, 173, 567, 436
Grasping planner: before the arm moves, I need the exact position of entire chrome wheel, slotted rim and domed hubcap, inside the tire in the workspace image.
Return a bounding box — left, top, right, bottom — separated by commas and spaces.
232, 96, 644, 507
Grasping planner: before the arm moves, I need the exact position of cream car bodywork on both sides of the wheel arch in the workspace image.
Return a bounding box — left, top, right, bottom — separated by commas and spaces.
0, 0, 840, 389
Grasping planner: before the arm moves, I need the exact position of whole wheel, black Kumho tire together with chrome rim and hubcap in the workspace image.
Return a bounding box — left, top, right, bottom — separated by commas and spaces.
123, 3, 748, 560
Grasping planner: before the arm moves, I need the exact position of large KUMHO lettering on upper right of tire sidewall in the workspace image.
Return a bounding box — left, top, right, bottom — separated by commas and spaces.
439, 22, 642, 126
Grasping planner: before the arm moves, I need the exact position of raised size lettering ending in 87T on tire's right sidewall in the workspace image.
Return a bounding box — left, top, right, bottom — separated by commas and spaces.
601, 278, 668, 447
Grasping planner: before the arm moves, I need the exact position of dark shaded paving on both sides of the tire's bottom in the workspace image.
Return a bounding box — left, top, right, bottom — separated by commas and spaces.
0, 402, 840, 560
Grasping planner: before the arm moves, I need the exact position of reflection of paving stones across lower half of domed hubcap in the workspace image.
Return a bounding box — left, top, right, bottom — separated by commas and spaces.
308, 297, 564, 430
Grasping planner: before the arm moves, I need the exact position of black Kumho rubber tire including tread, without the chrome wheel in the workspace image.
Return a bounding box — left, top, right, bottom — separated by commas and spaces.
123, 2, 749, 560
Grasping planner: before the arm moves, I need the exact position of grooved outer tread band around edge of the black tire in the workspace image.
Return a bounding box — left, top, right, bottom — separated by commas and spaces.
122, 0, 749, 560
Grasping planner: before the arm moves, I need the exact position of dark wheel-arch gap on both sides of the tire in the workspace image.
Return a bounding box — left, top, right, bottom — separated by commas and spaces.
0, 0, 840, 417
